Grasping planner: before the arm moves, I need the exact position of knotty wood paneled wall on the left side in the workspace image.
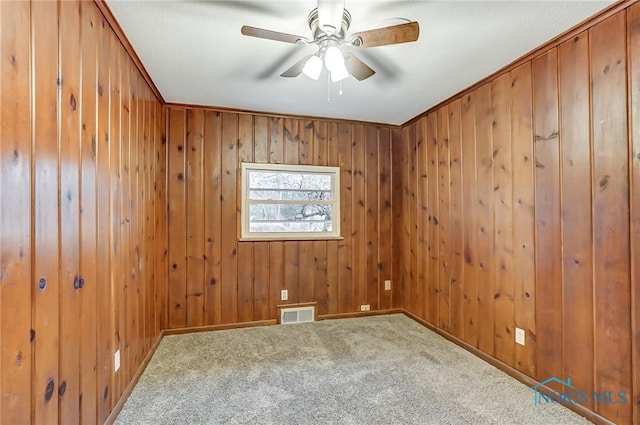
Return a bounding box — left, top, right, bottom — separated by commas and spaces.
0, 1, 167, 424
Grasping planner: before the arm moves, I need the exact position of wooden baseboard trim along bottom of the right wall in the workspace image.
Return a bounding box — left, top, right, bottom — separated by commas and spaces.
401, 309, 615, 425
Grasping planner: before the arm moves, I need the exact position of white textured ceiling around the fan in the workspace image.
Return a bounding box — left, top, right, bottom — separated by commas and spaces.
107, 0, 613, 124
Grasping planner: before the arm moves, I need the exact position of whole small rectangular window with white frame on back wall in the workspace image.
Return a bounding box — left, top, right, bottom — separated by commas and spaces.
241, 163, 340, 240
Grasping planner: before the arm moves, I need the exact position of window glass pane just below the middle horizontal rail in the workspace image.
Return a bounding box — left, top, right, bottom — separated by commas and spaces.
249, 204, 332, 224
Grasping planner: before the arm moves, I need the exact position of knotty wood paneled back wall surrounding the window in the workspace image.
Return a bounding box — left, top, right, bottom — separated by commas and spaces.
168, 108, 399, 328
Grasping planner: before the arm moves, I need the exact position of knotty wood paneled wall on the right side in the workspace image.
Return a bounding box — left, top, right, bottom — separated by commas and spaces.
393, 3, 640, 424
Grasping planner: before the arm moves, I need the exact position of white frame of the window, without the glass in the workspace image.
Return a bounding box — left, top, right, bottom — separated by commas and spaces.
240, 162, 342, 241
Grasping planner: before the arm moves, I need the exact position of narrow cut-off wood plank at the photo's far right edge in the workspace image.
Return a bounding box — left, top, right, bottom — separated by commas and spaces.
627, 4, 640, 423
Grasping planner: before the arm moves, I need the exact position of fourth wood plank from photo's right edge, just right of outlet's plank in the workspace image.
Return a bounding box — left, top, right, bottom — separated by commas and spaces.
532, 49, 564, 382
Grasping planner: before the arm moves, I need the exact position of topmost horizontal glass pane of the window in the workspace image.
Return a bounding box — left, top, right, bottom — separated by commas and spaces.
249, 170, 331, 191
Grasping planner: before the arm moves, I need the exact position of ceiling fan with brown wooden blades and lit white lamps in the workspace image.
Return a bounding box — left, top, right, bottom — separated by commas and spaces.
241, 0, 420, 83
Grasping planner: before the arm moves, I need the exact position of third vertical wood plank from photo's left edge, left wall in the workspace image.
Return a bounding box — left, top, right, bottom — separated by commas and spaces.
58, 1, 81, 423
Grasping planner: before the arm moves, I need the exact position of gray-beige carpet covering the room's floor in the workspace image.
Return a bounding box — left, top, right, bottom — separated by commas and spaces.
116, 314, 589, 425
